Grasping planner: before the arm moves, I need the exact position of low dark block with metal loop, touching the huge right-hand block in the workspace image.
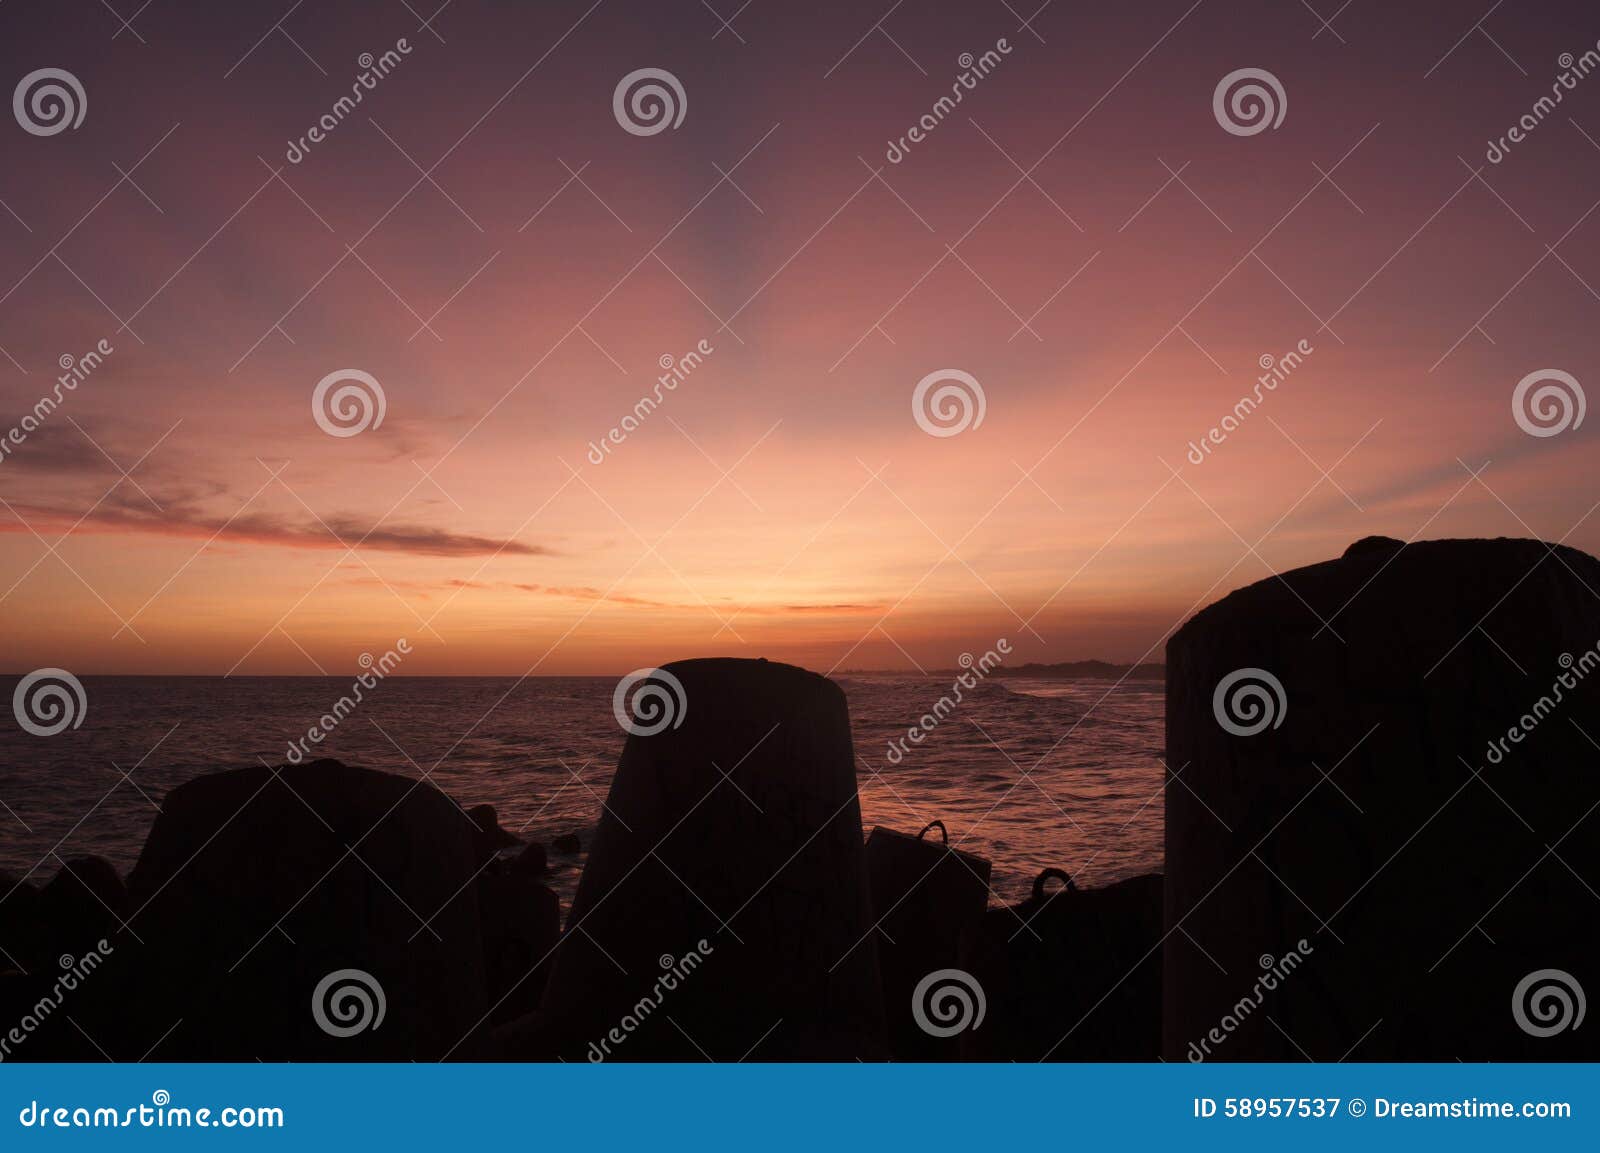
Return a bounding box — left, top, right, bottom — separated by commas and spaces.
960, 868, 1163, 1060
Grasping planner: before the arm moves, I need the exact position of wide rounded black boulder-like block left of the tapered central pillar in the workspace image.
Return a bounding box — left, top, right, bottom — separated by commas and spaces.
85, 760, 488, 1060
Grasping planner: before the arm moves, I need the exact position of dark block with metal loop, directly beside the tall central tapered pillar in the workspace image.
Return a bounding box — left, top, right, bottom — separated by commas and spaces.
867, 820, 990, 1060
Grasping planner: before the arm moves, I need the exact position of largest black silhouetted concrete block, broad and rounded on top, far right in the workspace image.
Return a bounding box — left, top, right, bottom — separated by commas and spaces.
1163, 537, 1600, 1060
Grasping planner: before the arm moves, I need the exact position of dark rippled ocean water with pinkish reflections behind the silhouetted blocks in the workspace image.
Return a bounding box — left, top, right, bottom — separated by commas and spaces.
0, 675, 1163, 907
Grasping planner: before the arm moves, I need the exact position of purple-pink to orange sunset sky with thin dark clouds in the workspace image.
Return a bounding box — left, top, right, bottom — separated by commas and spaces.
0, 0, 1600, 675
